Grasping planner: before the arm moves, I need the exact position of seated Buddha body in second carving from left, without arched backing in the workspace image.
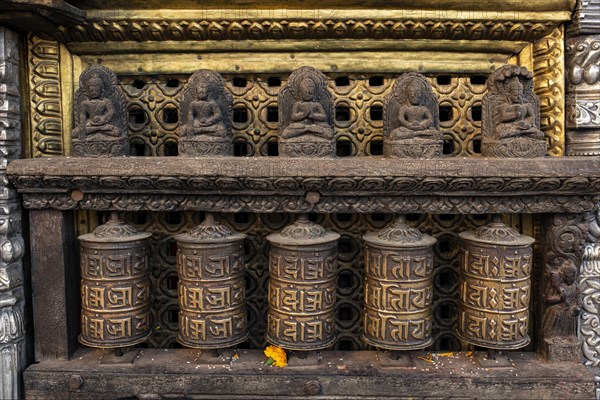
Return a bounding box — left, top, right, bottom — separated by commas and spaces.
183, 81, 227, 137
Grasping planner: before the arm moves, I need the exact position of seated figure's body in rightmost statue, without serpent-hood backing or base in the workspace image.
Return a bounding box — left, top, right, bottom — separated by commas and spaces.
496, 79, 544, 139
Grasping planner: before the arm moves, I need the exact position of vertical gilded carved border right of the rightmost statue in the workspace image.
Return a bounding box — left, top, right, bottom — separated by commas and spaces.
533, 26, 565, 156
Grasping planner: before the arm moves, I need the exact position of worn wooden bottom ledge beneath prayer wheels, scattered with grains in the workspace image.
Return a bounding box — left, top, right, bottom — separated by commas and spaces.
24, 349, 595, 399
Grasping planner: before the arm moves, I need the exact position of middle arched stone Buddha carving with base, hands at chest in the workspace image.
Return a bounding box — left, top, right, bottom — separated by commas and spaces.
278, 67, 334, 157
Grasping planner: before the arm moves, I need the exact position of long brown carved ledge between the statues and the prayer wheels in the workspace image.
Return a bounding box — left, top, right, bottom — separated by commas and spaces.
7, 157, 600, 213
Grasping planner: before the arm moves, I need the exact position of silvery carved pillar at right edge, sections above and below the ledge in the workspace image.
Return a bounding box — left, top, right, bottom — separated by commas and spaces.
565, 0, 600, 366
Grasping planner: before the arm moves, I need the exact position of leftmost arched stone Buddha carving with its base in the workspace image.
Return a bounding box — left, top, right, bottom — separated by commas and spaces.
71, 65, 129, 157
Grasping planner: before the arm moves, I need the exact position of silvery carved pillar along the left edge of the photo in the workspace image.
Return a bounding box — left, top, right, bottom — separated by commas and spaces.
0, 27, 27, 399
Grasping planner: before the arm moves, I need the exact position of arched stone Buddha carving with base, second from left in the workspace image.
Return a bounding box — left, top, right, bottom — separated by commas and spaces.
179, 69, 233, 156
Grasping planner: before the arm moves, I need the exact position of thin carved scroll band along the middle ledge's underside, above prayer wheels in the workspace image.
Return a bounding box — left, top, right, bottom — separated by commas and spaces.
17, 193, 600, 214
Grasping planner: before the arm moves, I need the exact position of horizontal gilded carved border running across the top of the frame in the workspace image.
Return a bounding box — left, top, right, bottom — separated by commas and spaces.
54, 17, 559, 43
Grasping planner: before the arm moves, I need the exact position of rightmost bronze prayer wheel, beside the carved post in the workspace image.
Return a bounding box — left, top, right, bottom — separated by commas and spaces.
458, 217, 534, 350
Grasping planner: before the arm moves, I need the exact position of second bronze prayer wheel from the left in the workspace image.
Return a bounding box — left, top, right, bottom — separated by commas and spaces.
175, 214, 248, 349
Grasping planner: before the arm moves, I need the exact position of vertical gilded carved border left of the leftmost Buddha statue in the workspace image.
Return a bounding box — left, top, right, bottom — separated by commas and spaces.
27, 35, 64, 157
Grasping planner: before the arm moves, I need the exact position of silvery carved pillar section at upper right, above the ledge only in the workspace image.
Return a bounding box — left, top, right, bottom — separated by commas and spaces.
565, 0, 600, 156
